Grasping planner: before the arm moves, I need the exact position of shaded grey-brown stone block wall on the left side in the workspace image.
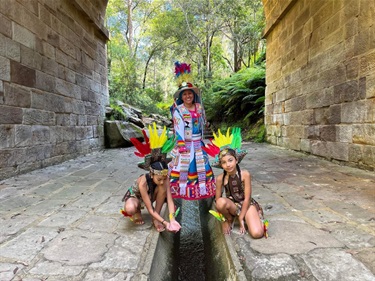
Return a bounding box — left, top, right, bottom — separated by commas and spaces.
0, 0, 108, 179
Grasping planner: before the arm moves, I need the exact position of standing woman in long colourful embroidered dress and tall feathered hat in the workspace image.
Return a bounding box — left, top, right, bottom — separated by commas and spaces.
169, 62, 215, 200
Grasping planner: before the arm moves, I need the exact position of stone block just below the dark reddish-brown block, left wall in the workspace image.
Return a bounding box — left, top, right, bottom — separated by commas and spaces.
4, 83, 31, 108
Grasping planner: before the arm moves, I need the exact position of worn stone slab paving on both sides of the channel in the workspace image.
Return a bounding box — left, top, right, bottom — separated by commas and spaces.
0, 143, 375, 281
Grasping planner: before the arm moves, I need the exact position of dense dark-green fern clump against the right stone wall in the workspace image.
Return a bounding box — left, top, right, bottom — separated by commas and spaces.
205, 67, 265, 126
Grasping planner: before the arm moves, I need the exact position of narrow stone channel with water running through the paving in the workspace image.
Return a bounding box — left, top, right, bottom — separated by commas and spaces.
147, 199, 245, 281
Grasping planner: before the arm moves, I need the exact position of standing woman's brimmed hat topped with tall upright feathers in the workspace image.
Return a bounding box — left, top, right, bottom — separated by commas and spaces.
174, 61, 199, 100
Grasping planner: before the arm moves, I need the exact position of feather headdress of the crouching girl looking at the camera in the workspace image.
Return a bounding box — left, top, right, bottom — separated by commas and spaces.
203, 127, 247, 168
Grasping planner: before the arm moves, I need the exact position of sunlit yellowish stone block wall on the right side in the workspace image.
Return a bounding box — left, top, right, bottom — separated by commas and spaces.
263, 0, 375, 170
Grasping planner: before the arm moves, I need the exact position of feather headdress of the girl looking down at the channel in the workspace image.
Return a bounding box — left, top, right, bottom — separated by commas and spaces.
130, 123, 176, 175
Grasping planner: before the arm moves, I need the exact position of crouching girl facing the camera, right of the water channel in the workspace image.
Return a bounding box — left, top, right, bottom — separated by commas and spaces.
205, 128, 268, 238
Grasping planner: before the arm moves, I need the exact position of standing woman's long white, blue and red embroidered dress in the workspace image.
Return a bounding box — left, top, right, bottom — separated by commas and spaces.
169, 103, 216, 200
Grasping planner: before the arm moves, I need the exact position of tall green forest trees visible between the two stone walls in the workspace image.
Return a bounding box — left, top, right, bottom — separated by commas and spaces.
106, 0, 265, 136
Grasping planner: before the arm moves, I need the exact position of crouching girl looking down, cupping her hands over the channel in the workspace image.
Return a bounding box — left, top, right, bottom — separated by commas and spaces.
121, 123, 181, 233
